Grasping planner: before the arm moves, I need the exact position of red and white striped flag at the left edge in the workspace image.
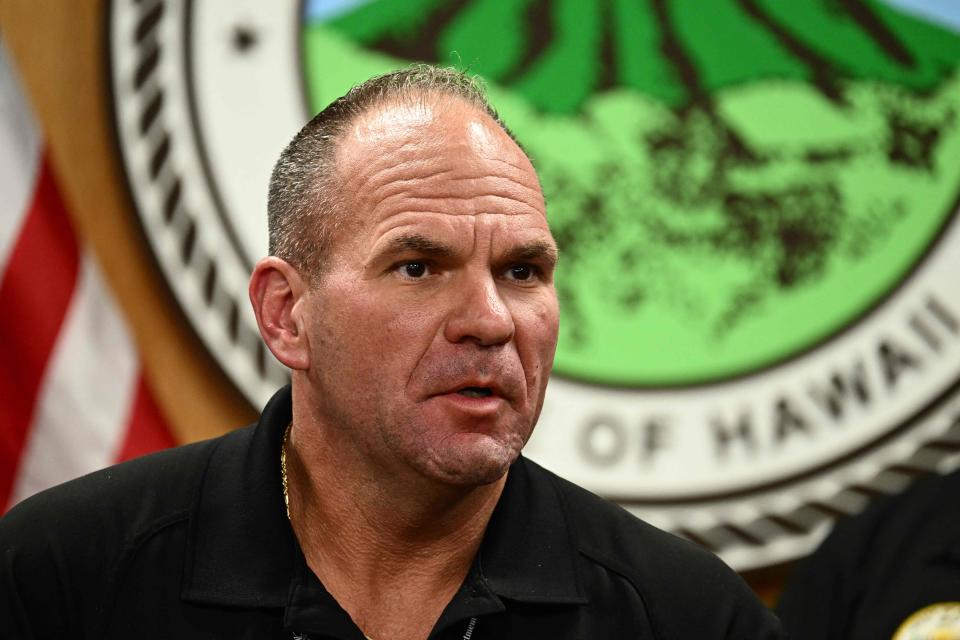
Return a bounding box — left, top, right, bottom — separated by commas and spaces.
0, 42, 174, 512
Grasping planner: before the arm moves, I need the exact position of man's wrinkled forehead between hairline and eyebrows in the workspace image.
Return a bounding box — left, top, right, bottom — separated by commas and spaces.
326, 97, 549, 254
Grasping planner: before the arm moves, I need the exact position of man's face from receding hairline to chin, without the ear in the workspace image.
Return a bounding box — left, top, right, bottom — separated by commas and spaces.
304, 99, 559, 484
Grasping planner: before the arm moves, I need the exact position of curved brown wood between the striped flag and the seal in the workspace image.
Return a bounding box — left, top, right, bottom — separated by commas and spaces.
0, 0, 256, 442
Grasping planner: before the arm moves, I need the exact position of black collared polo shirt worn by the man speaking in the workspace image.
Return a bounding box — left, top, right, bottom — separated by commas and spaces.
0, 389, 780, 640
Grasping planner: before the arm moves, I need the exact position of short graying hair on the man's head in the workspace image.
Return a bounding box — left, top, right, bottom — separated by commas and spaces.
267, 64, 516, 276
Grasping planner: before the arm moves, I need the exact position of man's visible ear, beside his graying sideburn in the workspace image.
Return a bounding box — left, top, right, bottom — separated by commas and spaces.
249, 256, 310, 369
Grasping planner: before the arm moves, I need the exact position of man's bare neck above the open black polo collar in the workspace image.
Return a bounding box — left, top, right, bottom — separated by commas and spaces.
286, 412, 506, 638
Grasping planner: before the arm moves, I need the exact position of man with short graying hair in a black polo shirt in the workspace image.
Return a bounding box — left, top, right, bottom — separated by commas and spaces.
0, 67, 780, 640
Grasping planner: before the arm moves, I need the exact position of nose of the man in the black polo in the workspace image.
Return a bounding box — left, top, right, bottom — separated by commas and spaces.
444, 275, 514, 347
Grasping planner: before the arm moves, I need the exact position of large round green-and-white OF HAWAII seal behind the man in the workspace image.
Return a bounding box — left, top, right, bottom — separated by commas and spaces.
110, 0, 960, 569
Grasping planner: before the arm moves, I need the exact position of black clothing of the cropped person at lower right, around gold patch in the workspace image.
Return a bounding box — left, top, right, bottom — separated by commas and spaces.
777, 464, 960, 640
